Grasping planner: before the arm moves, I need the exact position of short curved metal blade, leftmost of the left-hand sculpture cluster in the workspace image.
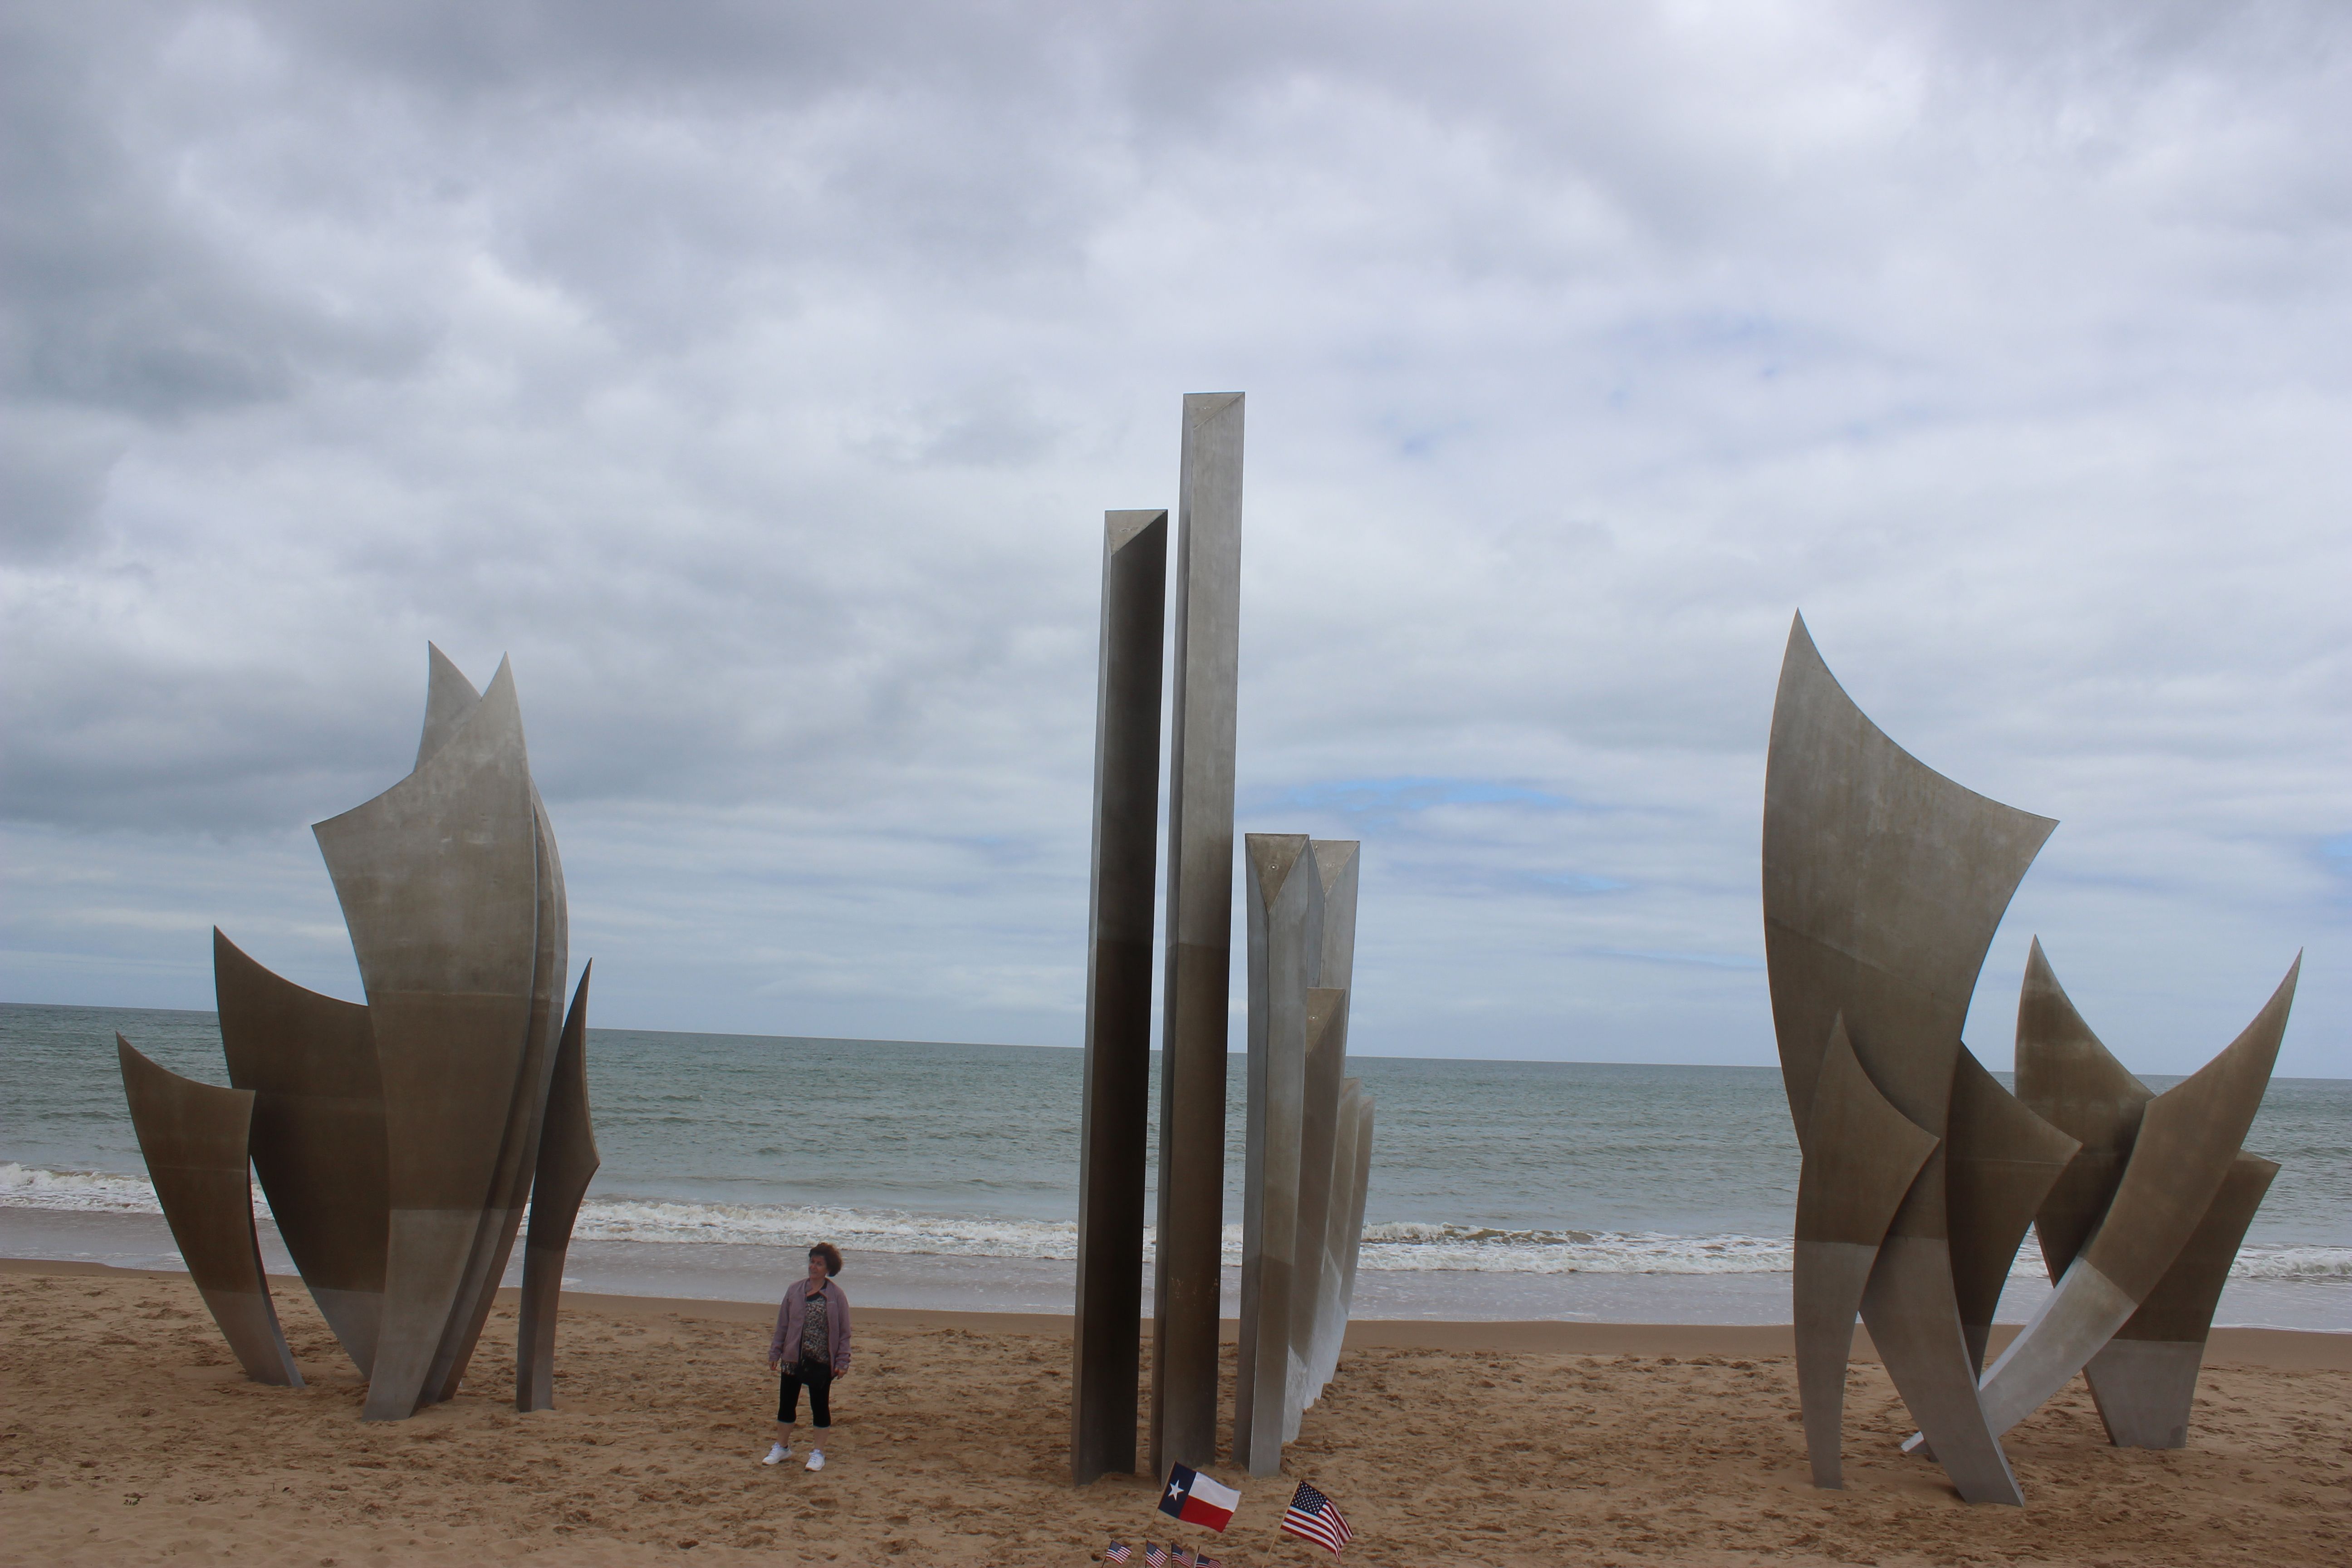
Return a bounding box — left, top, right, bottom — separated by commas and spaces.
115, 1034, 301, 1389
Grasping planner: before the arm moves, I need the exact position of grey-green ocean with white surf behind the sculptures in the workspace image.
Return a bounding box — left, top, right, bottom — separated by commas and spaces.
0, 1004, 2352, 1333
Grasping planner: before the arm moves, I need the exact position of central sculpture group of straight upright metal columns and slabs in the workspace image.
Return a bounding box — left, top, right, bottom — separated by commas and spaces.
1070, 392, 1371, 1486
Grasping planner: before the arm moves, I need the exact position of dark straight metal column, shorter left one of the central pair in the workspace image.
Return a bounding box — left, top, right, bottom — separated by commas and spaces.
1070, 508, 1169, 1486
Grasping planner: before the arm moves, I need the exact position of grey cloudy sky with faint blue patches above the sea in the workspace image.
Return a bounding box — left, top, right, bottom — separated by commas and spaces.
0, 0, 2352, 1077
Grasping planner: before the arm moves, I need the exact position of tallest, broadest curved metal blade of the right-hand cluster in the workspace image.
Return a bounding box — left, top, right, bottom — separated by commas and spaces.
1764, 618, 2056, 1502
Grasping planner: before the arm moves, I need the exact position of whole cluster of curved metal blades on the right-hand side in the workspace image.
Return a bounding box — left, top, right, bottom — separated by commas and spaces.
1764, 616, 2300, 1502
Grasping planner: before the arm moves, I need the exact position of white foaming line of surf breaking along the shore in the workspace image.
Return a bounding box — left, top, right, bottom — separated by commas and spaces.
0, 1161, 2352, 1281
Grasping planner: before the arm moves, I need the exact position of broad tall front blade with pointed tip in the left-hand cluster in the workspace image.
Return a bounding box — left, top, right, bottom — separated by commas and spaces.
313, 663, 541, 1420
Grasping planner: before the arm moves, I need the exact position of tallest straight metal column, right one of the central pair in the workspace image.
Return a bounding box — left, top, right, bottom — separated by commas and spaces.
1150, 392, 1242, 1474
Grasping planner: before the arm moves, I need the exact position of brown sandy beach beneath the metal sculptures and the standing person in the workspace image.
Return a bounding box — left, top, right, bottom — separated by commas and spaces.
0, 1260, 2352, 1568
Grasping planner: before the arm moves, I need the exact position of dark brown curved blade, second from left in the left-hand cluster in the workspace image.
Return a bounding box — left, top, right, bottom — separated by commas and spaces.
212, 926, 391, 1375
